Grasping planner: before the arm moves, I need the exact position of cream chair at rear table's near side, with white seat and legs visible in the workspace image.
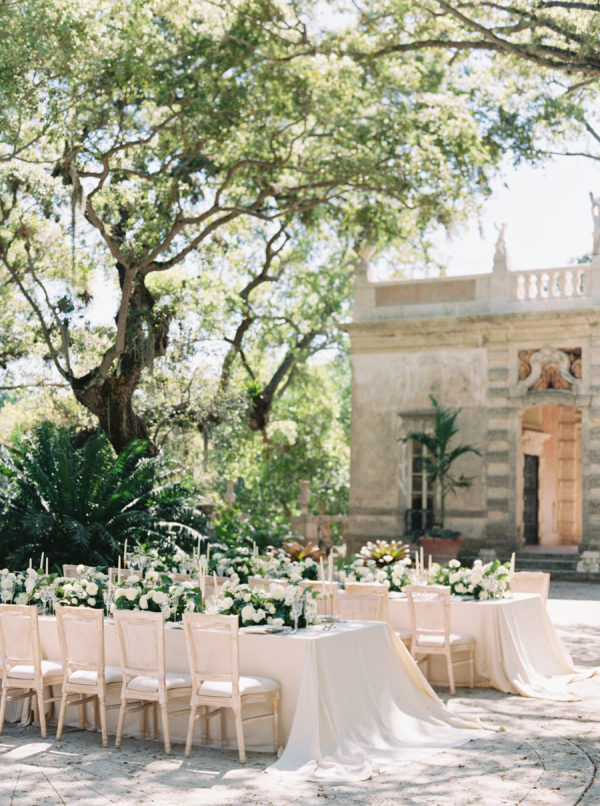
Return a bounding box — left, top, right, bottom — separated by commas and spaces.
405, 585, 475, 694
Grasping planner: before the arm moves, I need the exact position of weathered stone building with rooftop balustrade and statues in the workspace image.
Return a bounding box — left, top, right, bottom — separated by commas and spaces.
347, 229, 600, 557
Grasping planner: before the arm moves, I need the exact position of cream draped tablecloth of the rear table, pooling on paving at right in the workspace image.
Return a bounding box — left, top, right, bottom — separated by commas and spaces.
389, 593, 596, 701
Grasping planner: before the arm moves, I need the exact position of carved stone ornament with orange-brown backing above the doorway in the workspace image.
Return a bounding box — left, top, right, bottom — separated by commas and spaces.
516, 347, 581, 394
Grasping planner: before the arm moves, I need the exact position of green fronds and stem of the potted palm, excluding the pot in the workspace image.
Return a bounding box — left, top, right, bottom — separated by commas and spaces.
402, 395, 479, 531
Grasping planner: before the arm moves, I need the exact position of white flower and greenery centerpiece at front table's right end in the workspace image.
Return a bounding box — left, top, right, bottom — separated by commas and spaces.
218, 582, 317, 627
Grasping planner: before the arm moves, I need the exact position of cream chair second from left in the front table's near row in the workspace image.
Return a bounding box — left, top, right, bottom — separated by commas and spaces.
56, 605, 122, 747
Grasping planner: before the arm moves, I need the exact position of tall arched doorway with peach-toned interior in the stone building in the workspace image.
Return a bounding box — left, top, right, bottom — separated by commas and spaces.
518, 405, 582, 546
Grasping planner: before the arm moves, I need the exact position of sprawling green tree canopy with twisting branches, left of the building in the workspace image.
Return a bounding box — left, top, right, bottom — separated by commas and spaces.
0, 0, 552, 450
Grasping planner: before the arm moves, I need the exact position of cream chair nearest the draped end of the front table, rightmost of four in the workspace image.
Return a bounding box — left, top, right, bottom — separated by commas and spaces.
183, 613, 280, 764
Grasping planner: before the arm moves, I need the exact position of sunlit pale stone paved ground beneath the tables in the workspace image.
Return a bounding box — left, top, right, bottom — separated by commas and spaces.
0, 582, 600, 806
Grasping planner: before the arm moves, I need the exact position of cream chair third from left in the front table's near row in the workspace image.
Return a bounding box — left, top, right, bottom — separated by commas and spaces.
114, 610, 192, 755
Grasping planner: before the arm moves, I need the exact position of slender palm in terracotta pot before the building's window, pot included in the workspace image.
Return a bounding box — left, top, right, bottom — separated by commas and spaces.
402, 395, 479, 562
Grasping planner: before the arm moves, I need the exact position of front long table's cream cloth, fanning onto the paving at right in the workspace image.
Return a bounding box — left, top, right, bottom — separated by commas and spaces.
13, 617, 489, 781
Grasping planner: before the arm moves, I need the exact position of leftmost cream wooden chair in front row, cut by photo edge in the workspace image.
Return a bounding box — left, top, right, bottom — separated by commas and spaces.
0, 604, 63, 739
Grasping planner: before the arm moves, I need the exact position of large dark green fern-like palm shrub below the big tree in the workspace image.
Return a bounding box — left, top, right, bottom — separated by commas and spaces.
0, 423, 202, 568
